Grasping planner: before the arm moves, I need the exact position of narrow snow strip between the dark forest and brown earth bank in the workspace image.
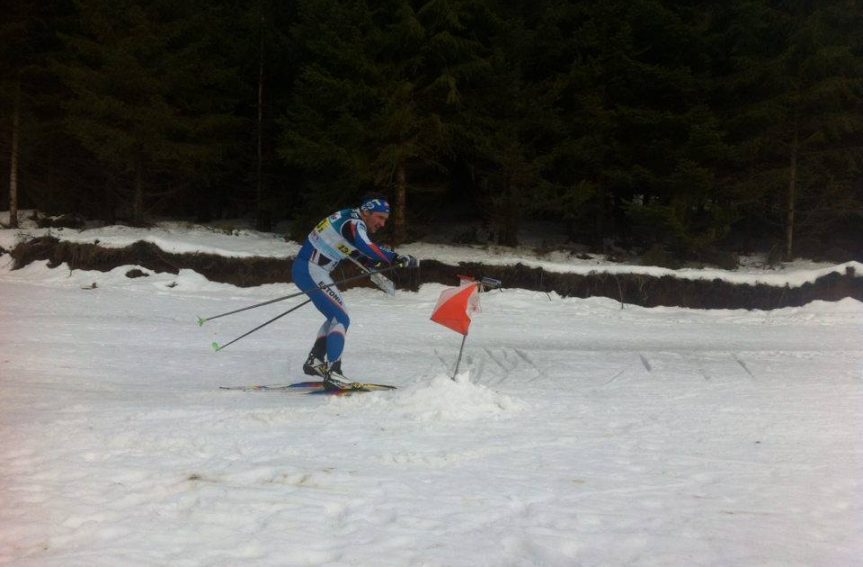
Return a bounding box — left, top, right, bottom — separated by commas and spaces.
0, 216, 863, 287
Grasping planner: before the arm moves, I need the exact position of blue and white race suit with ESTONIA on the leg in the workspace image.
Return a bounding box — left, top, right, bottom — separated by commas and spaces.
293, 209, 398, 365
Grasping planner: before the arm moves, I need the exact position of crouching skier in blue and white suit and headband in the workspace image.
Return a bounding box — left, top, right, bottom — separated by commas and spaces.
293, 196, 418, 390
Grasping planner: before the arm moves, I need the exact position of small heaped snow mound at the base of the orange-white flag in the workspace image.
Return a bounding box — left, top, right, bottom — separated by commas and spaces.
390, 372, 524, 421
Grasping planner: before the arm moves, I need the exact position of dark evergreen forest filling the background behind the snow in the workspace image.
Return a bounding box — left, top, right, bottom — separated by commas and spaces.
0, 0, 863, 261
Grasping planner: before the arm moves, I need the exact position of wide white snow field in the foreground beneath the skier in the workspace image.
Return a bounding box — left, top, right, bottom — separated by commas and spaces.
0, 220, 863, 567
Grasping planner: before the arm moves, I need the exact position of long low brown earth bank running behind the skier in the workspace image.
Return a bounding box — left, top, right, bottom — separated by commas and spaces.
10, 237, 863, 309
